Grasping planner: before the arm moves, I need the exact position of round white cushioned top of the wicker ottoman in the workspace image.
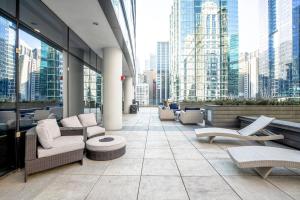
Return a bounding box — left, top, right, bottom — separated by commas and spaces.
86, 135, 126, 152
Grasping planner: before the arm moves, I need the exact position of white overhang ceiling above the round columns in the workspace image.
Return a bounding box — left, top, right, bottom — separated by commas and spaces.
42, 0, 130, 75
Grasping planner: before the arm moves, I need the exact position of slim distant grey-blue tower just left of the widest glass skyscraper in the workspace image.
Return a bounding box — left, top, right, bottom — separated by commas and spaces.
156, 42, 170, 103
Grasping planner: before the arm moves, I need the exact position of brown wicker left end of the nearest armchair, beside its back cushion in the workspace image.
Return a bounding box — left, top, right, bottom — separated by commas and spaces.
25, 127, 37, 161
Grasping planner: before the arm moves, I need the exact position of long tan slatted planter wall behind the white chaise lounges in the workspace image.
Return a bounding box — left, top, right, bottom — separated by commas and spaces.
205, 105, 300, 128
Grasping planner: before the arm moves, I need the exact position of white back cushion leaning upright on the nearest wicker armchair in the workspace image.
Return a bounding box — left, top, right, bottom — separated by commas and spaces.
35, 123, 53, 149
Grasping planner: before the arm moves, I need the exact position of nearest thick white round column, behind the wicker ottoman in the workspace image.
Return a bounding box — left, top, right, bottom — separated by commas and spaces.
103, 48, 122, 130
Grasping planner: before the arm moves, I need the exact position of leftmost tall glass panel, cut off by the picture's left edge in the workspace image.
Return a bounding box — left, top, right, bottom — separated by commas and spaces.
0, 16, 16, 176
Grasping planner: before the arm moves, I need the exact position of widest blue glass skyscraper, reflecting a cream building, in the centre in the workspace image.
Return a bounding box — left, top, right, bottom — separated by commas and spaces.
170, 0, 239, 100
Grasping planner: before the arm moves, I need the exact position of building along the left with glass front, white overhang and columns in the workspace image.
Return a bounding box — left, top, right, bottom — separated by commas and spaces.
0, 0, 136, 176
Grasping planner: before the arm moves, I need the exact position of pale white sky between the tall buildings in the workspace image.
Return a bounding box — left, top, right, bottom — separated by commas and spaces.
136, 0, 259, 71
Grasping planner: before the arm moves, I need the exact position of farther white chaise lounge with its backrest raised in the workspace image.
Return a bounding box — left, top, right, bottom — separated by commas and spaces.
195, 116, 284, 143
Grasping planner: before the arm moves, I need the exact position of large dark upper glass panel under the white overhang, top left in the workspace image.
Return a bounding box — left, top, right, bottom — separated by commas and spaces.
20, 0, 68, 49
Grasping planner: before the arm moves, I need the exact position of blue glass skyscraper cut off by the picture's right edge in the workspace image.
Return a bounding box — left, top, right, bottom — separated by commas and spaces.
259, 0, 300, 99
